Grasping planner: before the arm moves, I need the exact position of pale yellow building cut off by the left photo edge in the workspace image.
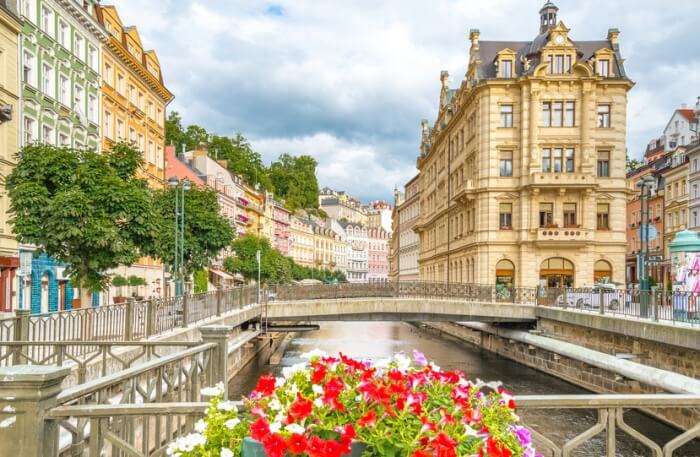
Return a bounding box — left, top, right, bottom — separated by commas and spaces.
0, 0, 20, 313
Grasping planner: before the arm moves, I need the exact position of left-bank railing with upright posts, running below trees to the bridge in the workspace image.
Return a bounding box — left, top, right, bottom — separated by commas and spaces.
0, 286, 257, 350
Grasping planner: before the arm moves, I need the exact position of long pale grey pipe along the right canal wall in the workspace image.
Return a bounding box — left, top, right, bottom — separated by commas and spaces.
457, 322, 700, 395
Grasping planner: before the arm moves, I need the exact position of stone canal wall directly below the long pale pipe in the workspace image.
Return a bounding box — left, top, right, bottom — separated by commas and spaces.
425, 322, 700, 430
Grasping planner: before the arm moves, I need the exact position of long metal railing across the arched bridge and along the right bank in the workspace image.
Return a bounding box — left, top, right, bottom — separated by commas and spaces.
267, 281, 700, 325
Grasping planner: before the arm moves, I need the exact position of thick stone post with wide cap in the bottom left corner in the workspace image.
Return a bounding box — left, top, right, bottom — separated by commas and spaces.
0, 365, 70, 457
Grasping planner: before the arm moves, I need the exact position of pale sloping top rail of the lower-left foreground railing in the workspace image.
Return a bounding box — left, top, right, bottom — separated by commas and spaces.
56, 343, 216, 405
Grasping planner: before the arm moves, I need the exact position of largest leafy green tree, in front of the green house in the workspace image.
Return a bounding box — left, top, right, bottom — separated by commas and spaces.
6, 143, 156, 300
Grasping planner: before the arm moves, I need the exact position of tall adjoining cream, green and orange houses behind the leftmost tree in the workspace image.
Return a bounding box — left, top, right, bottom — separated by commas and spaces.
0, 0, 173, 312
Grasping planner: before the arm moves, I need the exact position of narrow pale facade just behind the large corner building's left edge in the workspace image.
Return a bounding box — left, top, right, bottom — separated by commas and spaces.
392, 175, 420, 281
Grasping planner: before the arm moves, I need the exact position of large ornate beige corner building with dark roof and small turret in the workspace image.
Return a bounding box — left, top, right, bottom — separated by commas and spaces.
416, 2, 633, 287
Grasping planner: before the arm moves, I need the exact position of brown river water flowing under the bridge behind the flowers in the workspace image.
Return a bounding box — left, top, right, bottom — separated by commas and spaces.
230, 322, 700, 457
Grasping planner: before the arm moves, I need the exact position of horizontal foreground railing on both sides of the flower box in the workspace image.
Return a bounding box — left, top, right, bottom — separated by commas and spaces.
37, 394, 700, 457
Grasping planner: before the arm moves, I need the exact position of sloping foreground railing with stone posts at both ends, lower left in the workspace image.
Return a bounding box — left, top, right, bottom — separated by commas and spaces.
0, 326, 232, 457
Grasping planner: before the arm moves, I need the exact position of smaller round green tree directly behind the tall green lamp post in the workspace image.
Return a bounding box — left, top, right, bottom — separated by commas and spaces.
145, 187, 234, 275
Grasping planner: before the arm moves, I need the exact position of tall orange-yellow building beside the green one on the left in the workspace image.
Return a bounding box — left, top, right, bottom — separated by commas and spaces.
95, 5, 173, 187
